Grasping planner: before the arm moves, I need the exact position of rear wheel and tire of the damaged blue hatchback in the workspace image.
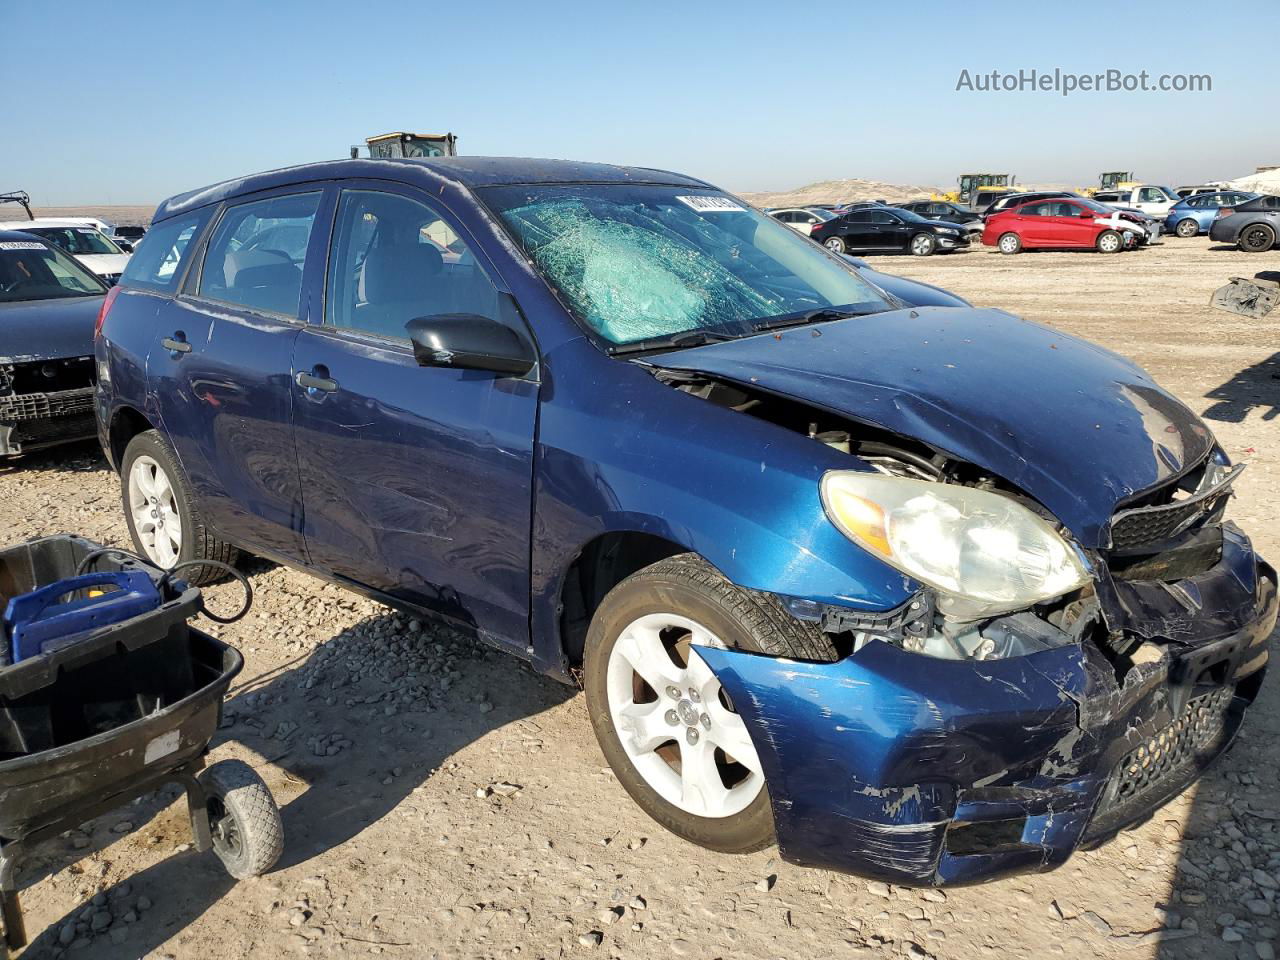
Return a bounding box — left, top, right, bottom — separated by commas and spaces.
120, 430, 239, 586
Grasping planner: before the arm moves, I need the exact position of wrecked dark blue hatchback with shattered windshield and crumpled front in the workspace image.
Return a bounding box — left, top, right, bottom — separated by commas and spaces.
97, 157, 1276, 884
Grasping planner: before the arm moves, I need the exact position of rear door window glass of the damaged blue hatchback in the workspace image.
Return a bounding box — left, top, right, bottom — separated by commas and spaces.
200, 193, 320, 317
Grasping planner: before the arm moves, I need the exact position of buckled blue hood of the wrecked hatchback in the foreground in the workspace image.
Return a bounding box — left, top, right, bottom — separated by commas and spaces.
650, 307, 1213, 547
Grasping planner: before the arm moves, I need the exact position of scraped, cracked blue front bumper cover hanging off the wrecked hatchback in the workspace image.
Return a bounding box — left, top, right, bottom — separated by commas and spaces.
699, 530, 1276, 886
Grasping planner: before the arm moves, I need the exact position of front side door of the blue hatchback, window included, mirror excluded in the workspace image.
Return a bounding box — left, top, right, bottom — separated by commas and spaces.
293, 183, 538, 650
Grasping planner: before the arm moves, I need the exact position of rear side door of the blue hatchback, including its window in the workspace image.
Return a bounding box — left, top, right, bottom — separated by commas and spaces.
148, 187, 325, 559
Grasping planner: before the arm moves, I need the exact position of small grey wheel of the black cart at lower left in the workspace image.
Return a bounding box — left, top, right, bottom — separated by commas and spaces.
200, 760, 284, 879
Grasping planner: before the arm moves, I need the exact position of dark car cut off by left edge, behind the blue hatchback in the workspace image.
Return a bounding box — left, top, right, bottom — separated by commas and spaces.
0, 230, 108, 458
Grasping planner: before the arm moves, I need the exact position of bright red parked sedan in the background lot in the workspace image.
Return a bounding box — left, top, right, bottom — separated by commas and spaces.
982, 197, 1142, 253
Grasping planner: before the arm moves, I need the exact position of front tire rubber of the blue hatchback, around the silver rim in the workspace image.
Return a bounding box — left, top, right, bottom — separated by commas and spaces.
584, 568, 773, 852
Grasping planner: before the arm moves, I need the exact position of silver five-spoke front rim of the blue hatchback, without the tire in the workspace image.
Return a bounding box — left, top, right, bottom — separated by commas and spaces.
605, 613, 764, 818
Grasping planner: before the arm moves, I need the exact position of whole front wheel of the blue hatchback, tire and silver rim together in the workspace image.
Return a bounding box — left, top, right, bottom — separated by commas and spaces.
584, 553, 837, 852
